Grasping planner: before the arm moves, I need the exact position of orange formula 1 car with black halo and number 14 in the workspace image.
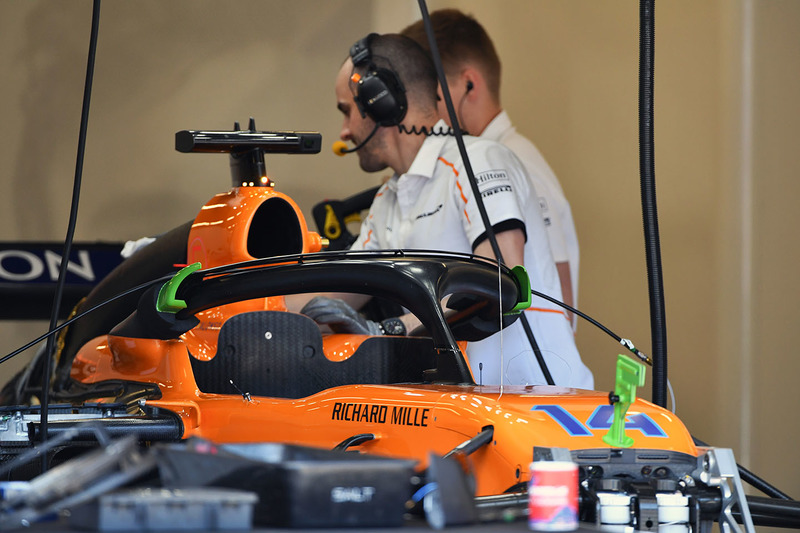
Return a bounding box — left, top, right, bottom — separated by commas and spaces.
0, 126, 780, 531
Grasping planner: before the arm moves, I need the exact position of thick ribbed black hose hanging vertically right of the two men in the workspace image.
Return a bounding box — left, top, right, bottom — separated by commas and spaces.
639, 0, 667, 407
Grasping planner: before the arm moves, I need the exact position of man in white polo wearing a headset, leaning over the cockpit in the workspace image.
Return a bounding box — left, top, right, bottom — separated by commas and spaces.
296, 34, 593, 389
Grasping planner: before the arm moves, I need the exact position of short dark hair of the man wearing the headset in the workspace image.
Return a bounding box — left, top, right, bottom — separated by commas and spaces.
356, 33, 439, 112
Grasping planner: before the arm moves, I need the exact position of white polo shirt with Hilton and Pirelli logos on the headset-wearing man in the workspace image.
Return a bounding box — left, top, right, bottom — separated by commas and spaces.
352, 121, 593, 388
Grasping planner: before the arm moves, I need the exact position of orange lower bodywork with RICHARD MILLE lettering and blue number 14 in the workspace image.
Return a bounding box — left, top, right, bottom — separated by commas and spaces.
72, 334, 698, 495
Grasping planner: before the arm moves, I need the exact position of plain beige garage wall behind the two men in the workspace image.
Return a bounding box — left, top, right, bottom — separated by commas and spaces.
0, 0, 800, 497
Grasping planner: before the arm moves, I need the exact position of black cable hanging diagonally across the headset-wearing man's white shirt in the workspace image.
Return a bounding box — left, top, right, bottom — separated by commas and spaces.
418, 0, 555, 385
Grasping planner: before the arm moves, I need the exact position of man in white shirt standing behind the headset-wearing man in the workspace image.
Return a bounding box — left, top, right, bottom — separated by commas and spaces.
400, 9, 579, 329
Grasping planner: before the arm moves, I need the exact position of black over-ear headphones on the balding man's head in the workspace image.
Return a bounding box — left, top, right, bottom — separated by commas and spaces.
350, 33, 408, 126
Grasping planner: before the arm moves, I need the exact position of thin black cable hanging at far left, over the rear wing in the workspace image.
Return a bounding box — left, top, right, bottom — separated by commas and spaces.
41, 0, 100, 472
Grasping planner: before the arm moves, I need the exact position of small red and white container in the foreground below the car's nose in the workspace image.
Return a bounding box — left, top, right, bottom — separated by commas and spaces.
528, 461, 578, 531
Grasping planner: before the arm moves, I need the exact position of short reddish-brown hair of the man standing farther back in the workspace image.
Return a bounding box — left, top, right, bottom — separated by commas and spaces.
400, 9, 501, 102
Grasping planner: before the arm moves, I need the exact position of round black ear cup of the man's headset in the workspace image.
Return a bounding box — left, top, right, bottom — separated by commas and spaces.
355, 68, 408, 126
